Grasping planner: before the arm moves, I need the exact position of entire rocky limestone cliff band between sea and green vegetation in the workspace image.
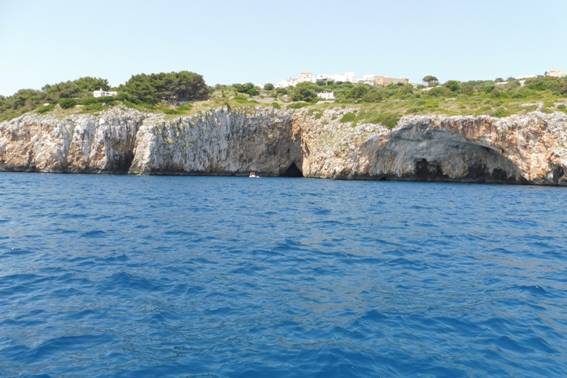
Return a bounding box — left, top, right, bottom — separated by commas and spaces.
0, 108, 567, 185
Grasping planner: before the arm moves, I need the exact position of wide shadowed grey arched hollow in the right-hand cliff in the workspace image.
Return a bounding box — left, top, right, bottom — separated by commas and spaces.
363, 126, 527, 184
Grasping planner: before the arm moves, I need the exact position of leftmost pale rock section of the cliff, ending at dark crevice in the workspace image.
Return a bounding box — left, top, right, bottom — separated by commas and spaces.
0, 109, 146, 172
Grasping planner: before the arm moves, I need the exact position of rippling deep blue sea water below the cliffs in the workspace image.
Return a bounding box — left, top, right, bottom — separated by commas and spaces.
0, 173, 567, 377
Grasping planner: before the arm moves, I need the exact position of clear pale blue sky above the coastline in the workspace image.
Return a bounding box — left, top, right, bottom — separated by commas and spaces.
0, 0, 567, 95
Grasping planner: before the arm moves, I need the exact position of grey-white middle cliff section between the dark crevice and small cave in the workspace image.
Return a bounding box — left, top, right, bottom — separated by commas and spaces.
130, 109, 301, 176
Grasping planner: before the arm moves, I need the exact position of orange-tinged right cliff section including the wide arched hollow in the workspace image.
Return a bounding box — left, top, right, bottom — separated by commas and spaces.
295, 110, 567, 185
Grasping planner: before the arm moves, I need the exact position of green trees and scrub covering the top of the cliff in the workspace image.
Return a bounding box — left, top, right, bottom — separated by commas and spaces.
0, 71, 567, 126
